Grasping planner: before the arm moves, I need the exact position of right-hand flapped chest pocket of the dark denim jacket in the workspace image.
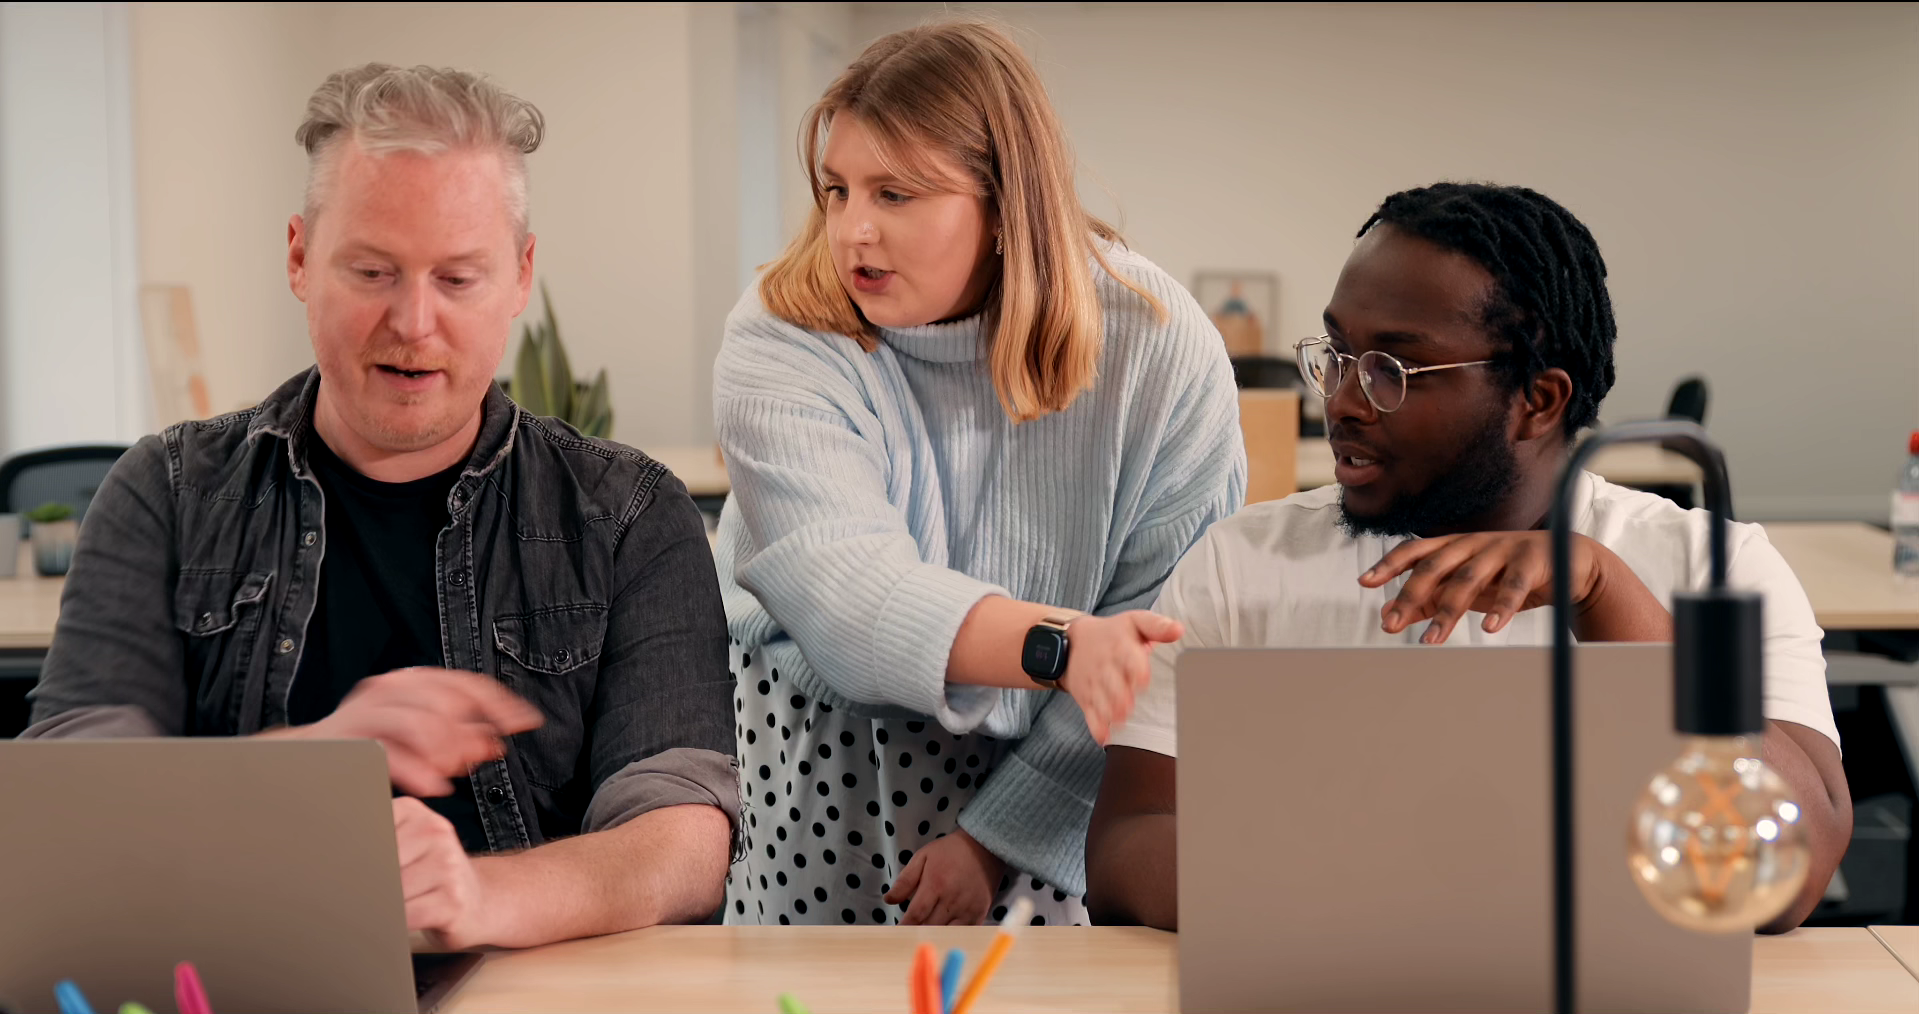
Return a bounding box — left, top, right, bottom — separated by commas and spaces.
493, 605, 606, 789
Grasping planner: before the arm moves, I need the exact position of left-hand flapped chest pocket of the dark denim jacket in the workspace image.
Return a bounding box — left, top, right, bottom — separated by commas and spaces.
173, 570, 272, 734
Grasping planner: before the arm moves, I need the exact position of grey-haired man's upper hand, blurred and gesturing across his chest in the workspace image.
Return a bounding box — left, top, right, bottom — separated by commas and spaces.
272, 666, 541, 795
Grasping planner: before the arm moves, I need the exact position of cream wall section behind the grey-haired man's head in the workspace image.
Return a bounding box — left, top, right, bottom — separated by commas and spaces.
134, 4, 737, 447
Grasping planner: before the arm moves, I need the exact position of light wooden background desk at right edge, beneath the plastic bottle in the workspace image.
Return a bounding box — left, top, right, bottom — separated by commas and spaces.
1765, 520, 1919, 630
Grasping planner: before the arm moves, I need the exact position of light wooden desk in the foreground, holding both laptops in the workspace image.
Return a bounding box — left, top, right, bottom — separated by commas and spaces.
443, 926, 1919, 1014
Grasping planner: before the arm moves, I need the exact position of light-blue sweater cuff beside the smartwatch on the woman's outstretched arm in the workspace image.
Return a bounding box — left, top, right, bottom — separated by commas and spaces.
873, 563, 1007, 736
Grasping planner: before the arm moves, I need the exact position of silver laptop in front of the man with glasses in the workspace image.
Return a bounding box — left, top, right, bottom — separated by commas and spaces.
1178, 645, 1752, 1014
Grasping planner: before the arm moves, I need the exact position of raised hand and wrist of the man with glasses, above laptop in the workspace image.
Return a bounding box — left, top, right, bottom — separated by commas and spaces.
1359, 532, 1671, 643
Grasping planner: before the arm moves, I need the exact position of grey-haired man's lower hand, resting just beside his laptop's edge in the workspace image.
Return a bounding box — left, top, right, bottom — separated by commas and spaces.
393, 795, 493, 951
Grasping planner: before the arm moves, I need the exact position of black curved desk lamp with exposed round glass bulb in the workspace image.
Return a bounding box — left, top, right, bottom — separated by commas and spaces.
1552, 419, 1810, 1014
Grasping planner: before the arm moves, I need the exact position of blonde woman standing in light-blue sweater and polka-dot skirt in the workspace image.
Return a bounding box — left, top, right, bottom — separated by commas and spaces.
714, 23, 1245, 926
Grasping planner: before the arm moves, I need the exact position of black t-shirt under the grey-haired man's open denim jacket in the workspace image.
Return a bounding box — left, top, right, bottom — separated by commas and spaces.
288, 432, 487, 853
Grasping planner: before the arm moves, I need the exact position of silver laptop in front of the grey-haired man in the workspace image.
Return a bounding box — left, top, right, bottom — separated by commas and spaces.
0, 739, 478, 1014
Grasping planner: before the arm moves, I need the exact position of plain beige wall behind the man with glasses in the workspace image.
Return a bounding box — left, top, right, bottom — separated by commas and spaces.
854, 4, 1919, 520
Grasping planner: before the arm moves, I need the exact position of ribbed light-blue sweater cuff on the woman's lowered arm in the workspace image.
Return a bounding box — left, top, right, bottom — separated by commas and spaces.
960, 710, 1105, 895
